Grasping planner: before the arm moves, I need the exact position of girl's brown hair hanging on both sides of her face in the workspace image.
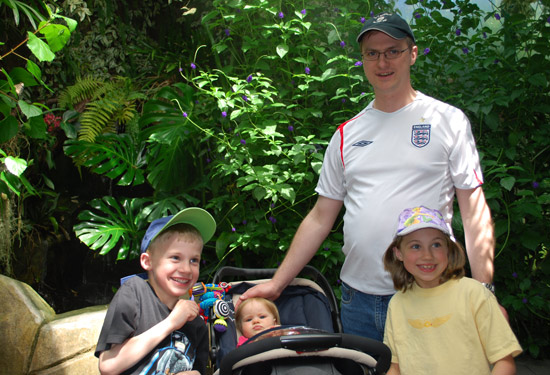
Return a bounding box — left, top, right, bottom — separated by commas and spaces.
384, 232, 466, 292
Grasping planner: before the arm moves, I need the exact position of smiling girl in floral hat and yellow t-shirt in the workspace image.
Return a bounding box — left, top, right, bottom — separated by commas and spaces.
384, 206, 522, 375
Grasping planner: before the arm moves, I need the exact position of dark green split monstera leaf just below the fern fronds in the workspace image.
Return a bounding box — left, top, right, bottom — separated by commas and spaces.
64, 134, 145, 186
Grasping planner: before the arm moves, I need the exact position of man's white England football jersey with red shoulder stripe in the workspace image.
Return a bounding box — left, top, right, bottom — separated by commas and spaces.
315, 92, 483, 295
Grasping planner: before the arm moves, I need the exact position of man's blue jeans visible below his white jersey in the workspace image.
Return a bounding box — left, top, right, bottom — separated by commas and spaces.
340, 282, 393, 341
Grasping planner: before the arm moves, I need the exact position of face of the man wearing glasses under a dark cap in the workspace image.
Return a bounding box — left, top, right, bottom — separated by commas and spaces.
361, 31, 418, 96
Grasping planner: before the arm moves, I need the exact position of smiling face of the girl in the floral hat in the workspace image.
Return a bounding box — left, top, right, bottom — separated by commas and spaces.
393, 228, 449, 288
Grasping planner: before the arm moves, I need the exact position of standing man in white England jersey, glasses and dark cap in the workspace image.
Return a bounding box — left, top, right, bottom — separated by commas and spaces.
237, 13, 494, 341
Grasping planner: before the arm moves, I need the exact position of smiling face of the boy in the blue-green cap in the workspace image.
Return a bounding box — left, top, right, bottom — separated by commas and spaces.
140, 232, 202, 308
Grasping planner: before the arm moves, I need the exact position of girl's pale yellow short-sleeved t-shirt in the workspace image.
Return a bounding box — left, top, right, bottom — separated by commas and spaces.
384, 277, 522, 375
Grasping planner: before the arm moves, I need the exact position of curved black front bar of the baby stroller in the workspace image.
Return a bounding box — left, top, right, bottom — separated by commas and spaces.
219, 333, 391, 375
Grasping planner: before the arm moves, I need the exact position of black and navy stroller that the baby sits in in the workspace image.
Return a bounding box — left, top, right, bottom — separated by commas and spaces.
203, 266, 391, 375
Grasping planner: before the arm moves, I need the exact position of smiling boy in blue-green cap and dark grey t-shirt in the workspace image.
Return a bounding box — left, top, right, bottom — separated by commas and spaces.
95, 207, 216, 375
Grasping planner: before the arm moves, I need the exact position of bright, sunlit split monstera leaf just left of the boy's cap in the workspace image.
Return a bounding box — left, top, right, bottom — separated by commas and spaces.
73, 197, 148, 260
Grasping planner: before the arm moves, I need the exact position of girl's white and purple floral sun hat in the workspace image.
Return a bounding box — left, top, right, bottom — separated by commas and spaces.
396, 206, 452, 237
